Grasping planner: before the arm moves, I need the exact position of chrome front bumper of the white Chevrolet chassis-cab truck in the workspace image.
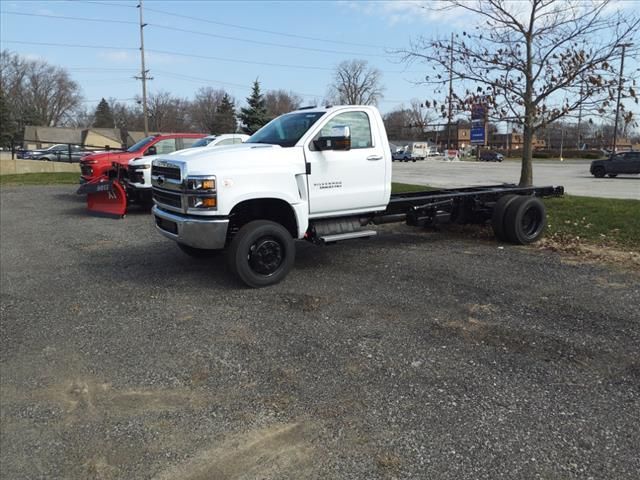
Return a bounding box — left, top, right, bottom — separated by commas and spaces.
151, 205, 229, 250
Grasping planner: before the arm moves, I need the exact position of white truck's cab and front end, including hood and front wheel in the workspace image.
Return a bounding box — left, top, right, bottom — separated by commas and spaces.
151, 106, 391, 286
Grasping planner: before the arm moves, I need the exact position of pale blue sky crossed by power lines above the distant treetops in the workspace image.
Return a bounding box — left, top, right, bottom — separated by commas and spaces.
0, 0, 640, 118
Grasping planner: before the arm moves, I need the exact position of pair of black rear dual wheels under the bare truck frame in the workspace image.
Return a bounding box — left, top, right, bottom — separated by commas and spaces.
491, 195, 547, 245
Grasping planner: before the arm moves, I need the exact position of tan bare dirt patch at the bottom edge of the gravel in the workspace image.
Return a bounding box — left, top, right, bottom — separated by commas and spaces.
154, 422, 315, 480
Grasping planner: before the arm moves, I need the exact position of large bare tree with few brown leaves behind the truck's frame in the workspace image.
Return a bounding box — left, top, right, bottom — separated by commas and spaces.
401, 0, 640, 185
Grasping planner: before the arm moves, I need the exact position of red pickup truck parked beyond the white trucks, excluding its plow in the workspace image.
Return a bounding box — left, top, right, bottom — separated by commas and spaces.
80, 133, 206, 183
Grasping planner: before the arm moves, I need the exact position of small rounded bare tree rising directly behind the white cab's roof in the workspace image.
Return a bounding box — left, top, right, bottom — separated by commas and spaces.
328, 60, 384, 105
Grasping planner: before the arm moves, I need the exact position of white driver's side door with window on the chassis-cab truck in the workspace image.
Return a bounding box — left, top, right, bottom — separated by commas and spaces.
304, 111, 388, 216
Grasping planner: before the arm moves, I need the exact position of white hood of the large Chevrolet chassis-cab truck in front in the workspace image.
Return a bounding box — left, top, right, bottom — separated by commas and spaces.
156, 143, 304, 175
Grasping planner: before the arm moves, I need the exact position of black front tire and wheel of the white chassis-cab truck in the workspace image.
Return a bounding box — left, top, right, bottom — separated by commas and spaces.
227, 220, 295, 288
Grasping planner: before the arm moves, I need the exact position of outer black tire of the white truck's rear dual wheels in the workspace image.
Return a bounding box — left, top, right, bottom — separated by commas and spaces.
504, 196, 547, 245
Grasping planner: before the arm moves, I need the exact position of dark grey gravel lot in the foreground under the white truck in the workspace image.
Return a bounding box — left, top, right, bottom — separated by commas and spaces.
0, 185, 640, 480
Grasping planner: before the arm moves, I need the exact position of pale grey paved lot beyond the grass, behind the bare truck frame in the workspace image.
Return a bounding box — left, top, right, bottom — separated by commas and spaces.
393, 159, 640, 200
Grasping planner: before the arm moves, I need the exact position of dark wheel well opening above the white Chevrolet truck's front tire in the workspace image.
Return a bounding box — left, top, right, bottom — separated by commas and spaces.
229, 198, 298, 238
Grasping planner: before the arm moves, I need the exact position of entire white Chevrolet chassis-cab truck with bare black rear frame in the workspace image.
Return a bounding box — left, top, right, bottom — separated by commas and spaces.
151, 106, 563, 287
